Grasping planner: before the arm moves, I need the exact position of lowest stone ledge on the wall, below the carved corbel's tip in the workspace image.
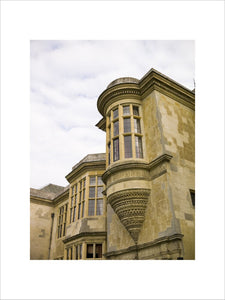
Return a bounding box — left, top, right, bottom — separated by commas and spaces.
105, 233, 184, 257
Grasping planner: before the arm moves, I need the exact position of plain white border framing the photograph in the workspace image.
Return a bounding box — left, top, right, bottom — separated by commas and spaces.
1, 1, 224, 299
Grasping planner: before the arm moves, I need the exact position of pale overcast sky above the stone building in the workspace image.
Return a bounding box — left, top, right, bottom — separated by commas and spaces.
30, 41, 195, 188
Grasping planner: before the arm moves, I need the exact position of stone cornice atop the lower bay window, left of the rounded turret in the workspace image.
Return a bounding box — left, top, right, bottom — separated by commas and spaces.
66, 160, 105, 183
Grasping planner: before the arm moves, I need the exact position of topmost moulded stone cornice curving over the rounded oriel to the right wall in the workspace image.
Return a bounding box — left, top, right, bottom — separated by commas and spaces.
97, 69, 195, 117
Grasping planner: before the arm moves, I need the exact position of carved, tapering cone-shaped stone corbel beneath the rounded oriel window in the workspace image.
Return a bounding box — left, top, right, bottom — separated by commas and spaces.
108, 189, 150, 243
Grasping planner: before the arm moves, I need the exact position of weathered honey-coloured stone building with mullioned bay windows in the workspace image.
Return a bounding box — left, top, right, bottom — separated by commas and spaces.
30, 69, 195, 259
